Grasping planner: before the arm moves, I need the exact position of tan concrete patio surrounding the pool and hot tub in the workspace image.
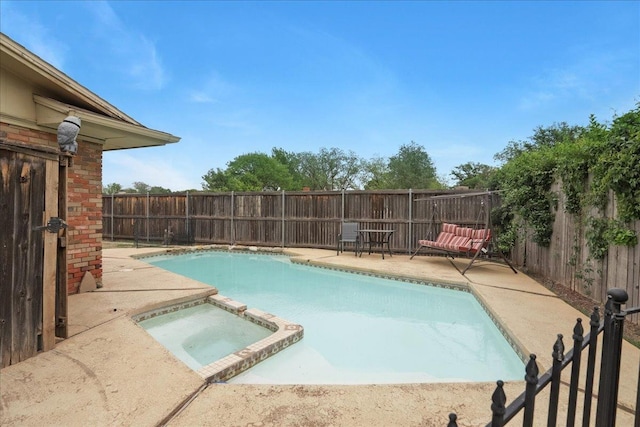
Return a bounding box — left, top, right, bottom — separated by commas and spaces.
0, 248, 640, 426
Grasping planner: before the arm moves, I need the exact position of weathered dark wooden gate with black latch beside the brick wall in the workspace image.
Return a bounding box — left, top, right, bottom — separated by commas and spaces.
0, 142, 66, 367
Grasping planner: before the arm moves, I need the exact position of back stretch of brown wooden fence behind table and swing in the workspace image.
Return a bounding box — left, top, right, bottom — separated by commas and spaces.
102, 190, 497, 253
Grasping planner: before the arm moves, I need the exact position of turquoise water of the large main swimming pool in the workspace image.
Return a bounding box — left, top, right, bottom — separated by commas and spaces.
147, 251, 524, 384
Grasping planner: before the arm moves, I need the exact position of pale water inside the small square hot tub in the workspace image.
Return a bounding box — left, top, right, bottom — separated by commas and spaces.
138, 303, 273, 371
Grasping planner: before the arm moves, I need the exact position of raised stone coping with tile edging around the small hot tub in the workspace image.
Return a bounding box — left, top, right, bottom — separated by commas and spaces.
130, 288, 304, 383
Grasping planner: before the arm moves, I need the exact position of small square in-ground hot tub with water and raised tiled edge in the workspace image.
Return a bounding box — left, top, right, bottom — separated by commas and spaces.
133, 295, 304, 382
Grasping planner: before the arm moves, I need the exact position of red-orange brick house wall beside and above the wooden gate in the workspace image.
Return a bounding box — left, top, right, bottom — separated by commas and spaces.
0, 123, 102, 294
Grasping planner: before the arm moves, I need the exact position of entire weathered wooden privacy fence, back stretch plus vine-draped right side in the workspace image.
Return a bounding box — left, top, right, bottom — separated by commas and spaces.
102, 191, 640, 323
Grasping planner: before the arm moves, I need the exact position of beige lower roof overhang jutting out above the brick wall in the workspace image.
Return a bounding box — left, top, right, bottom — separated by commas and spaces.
33, 95, 180, 151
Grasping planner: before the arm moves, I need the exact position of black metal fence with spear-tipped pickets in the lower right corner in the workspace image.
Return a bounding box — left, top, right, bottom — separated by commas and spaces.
447, 289, 640, 427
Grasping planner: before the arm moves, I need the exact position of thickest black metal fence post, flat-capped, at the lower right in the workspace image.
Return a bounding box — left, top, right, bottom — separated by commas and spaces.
596, 288, 629, 427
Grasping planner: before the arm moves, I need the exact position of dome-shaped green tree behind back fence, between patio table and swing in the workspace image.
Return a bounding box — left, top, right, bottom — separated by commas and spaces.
384, 141, 442, 189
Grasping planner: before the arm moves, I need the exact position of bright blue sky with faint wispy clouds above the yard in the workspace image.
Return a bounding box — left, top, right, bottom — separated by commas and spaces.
0, 0, 640, 190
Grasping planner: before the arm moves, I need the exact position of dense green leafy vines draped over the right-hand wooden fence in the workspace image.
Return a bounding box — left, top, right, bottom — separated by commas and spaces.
496, 104, 640, 258
